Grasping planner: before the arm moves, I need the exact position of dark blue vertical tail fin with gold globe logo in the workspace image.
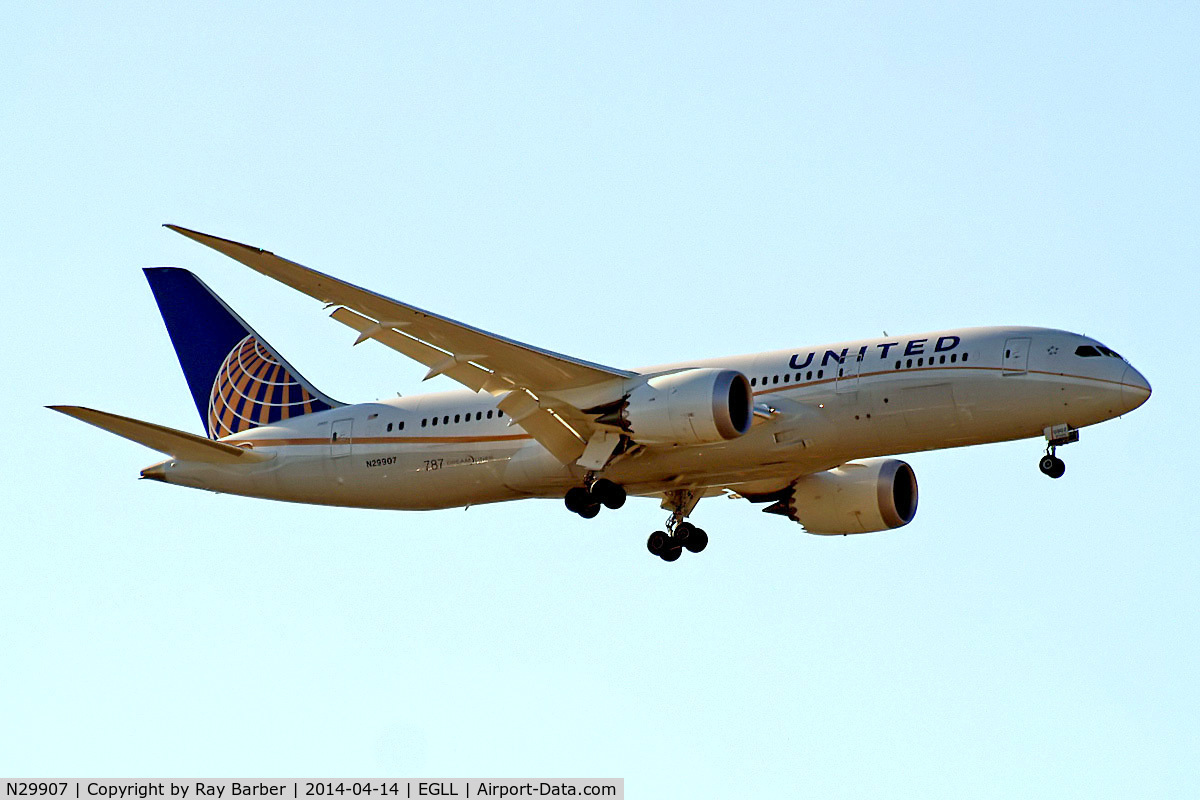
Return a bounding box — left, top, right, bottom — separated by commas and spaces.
143, 266, 342, 439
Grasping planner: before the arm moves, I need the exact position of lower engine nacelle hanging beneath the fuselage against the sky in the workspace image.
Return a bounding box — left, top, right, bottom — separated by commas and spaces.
786, 458, 917, 535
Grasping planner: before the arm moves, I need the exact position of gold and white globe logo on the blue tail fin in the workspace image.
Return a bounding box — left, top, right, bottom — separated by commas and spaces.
208, 336, 328, 439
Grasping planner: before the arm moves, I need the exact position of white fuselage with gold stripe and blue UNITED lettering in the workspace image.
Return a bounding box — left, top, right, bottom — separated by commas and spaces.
144, 327, 1150, 509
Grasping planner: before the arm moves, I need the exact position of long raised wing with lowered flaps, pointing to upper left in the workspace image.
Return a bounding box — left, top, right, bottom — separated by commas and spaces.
167, 224, 636, 463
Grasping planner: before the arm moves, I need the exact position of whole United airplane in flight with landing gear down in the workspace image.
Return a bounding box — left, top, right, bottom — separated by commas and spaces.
48, 225, 1151, 561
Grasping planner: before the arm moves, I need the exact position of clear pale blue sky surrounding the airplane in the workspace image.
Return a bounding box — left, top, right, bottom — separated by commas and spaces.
0, 2, 1200, 799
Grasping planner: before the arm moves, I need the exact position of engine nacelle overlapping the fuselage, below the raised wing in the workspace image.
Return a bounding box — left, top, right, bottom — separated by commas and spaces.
623, 368, 754, 445
